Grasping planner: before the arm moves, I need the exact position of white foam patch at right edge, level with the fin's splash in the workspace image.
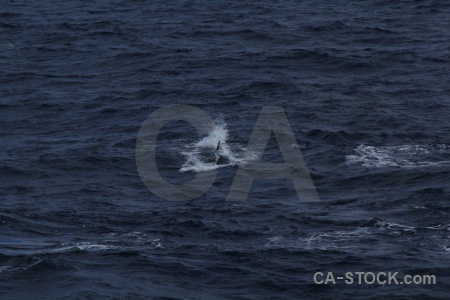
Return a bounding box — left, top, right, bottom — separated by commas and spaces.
346, 144, 450, 168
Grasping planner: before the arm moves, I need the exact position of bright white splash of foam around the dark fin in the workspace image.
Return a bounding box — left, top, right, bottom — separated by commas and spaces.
180, 120, 244, 173
